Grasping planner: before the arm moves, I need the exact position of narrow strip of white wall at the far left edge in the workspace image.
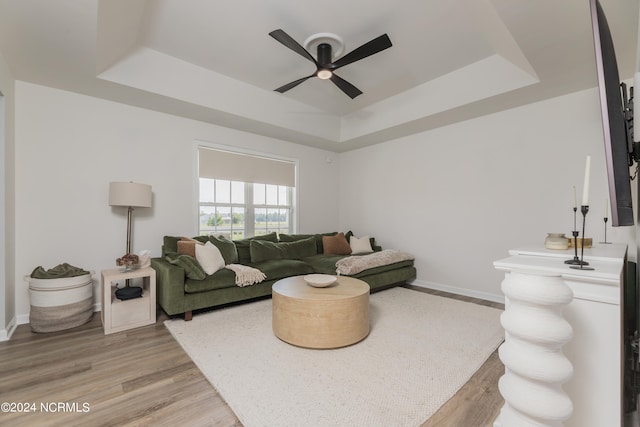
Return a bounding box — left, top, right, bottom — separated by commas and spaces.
0, 51, 16, 341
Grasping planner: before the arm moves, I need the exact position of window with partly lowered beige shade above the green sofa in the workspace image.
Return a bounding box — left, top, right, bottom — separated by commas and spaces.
198, 146, 295, 239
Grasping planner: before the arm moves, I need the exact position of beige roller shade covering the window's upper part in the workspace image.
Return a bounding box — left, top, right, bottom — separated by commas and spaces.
198, 147, 296, 187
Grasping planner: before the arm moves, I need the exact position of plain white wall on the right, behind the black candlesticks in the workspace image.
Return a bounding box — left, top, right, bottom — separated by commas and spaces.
340, 89, 635, 301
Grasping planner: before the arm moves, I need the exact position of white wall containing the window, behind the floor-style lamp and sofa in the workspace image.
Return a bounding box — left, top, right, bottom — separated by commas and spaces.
15, 81, 339, 323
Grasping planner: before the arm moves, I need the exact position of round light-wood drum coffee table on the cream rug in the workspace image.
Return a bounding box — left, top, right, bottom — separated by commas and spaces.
272, 276, 369, 348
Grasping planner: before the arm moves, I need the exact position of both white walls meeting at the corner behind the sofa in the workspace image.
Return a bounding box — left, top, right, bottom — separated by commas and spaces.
14, 82, 635, 322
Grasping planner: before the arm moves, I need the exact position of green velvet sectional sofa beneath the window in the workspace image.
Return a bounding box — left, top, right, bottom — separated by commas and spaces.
151, 232, 416, 320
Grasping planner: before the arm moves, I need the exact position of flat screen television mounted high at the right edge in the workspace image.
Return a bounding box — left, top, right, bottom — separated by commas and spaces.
590, 0, 634, 227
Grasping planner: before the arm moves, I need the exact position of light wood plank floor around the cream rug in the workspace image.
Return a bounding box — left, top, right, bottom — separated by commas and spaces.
0, 285, 504, 427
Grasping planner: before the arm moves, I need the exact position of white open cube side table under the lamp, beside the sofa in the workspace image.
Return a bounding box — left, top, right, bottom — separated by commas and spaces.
101, 267, 156, 335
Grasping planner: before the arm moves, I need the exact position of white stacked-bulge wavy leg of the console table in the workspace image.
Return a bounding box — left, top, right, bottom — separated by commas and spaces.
494, 272, 573, 427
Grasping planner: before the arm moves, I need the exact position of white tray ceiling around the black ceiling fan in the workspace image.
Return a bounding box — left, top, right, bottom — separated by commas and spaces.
0, 0, 638, 152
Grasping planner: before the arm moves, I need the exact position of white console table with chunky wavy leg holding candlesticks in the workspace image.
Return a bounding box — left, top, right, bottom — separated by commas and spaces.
494, 244, 627, 427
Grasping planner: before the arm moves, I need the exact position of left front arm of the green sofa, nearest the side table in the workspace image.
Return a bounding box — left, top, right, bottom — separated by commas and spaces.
151, 258, 186, 316
